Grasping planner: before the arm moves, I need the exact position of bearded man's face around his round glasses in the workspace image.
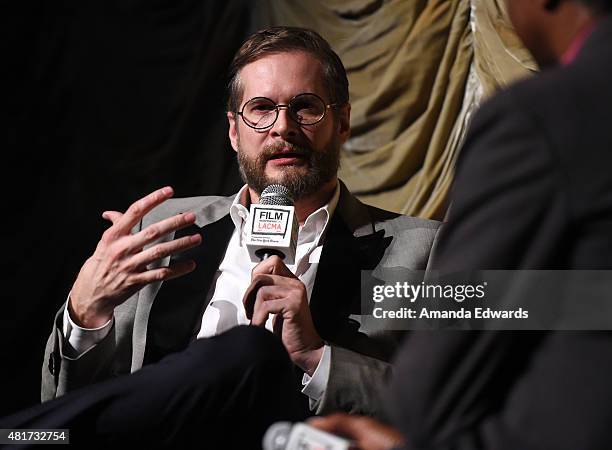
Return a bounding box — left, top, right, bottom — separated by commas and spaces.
228, 52, 349, 200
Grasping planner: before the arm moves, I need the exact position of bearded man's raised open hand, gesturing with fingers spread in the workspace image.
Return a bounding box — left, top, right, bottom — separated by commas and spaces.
68, 187, 202, 328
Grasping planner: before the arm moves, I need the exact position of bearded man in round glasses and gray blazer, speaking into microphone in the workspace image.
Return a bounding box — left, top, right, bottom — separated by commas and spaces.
25, 27, 439, 445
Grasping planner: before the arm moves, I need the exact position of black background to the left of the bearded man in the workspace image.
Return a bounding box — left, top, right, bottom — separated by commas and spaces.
0, 0, 256, 415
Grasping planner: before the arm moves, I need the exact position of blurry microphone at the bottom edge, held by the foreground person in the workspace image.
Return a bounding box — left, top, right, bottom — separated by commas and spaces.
262, 422, 351, 450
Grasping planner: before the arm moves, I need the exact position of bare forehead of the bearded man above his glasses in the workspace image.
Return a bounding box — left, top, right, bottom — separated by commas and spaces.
239, 51, 326, 100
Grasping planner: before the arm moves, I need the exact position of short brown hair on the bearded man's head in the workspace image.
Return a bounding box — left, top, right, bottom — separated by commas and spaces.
227, 27, 349, 112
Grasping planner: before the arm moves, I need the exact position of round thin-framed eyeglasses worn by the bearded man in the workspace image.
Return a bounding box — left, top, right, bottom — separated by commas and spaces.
236, 93, 338, 130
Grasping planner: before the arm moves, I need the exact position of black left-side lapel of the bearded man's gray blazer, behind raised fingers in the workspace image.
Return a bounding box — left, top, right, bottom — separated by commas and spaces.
143, 214, 234, 364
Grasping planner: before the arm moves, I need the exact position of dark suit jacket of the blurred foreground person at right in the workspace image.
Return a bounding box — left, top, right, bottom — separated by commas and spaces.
389, 18, 612, 450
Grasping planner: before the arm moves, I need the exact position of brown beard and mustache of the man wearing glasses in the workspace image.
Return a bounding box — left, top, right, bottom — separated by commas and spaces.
238, 137, 340, 200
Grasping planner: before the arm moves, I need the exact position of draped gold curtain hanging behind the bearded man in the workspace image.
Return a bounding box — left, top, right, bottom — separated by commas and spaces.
255, 0, 535, 219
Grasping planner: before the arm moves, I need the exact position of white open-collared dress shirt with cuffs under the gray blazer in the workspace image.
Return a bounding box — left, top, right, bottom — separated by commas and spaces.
63, 185, 340, 408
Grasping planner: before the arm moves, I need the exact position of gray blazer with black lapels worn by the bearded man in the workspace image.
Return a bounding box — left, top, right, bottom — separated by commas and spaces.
41, 183, 440, 415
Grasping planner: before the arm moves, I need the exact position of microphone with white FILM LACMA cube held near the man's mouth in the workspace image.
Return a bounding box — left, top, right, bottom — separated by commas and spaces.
246, 184, 298, 265
